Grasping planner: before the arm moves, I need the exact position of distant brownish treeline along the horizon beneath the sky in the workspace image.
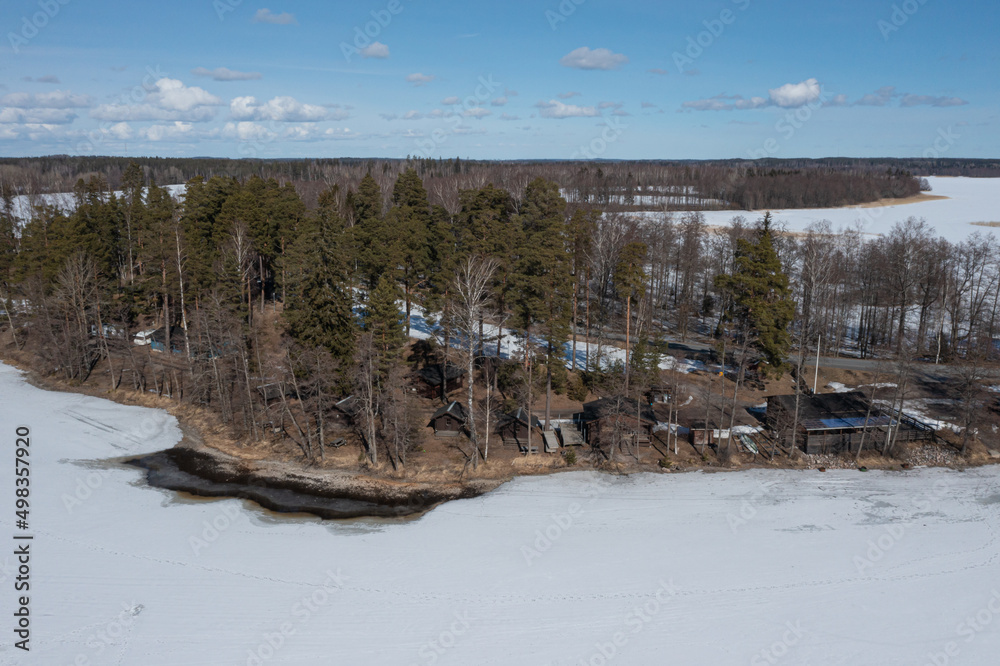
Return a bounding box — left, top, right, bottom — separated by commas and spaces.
0, 155, 1000, 212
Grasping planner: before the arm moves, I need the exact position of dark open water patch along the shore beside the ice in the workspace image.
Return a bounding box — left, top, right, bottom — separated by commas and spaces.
125, 448, 441, 520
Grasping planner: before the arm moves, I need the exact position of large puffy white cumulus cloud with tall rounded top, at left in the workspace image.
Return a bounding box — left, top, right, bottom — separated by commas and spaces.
90, 78, 223, 122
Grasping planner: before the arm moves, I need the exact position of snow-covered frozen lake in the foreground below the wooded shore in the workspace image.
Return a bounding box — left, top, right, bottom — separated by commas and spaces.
0, 358, 1000, 666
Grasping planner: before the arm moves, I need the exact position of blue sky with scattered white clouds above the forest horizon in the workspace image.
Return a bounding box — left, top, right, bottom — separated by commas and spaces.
0, 0, 1000, 159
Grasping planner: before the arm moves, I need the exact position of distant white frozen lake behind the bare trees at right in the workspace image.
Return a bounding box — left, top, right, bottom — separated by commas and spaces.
644, 177, 1000, 242
